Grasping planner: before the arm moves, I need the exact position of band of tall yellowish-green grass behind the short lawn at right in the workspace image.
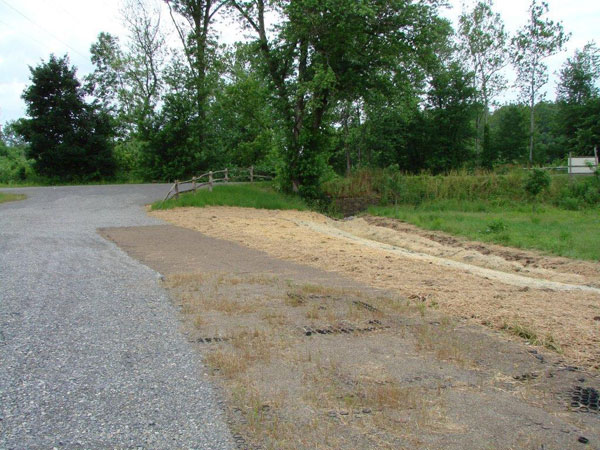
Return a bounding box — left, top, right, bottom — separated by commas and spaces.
324, 169, 600, 209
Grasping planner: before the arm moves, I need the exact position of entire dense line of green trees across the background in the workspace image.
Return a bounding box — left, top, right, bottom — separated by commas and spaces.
0, 0, 600, 198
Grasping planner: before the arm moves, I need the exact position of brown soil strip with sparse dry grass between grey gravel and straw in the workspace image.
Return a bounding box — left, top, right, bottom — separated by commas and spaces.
101, 225, 600, 449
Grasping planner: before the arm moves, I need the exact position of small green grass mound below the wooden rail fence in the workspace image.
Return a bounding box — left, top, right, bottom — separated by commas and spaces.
152, 183, 308, 211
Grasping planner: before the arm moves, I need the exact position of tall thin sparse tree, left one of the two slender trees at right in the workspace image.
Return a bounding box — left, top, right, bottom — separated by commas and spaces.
458, 0, 509, 156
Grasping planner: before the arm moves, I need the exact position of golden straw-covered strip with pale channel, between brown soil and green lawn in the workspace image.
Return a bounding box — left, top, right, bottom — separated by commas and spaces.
151, 207, 600, 368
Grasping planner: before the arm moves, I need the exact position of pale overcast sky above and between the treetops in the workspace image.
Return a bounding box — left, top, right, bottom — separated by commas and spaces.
0, 0, 600, 123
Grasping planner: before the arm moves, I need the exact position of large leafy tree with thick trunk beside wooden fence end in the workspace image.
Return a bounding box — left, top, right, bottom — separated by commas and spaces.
231, 0, 450, 197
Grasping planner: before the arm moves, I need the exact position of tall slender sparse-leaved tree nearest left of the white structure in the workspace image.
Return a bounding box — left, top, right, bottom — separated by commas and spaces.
511, 0, 570, 164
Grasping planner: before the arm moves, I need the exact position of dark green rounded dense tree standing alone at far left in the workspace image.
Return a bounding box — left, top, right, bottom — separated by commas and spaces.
18, 55, 114, 180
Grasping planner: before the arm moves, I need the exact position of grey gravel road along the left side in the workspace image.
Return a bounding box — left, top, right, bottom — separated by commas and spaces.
0, 185, 232, 449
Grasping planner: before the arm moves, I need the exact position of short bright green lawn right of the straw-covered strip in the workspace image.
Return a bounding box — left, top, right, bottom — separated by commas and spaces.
369, 200, 600, 261
